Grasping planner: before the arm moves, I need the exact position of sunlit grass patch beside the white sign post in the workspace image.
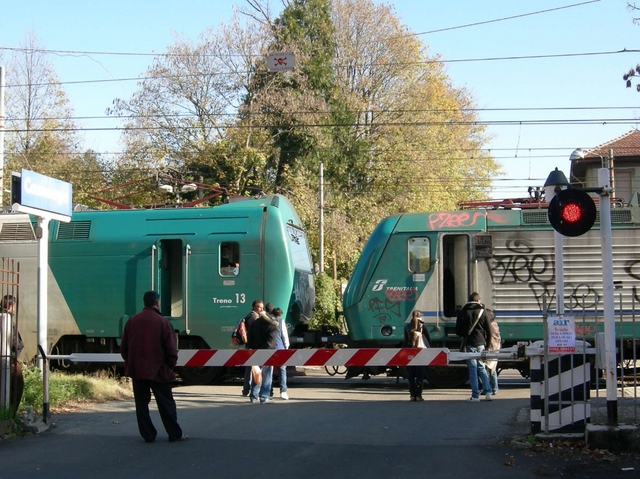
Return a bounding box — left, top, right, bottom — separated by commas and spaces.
20, 366, 133, 412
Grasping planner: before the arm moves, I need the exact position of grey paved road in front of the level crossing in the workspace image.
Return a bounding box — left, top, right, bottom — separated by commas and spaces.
0, 371, 638, 479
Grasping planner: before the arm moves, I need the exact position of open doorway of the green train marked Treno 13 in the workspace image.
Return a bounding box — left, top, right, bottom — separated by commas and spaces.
152, 239, 188, 318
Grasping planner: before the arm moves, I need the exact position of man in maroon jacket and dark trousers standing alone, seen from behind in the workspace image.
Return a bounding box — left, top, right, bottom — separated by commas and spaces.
120, 291, 189, 442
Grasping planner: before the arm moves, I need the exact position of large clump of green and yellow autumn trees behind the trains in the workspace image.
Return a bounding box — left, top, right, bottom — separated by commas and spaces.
107, 0, 499, 281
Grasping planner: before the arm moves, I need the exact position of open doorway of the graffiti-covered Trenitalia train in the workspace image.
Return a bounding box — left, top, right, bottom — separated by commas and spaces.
441, 234, 470, 318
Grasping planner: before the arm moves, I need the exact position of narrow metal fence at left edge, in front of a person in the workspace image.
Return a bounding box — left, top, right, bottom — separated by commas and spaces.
0, 258, 20, 420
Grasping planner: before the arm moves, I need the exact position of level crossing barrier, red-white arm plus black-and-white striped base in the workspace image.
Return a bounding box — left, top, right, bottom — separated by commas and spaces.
46, 341, 595, 434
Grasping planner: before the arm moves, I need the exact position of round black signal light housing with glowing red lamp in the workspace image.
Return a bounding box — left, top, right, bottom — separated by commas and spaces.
547, 188, 596, 236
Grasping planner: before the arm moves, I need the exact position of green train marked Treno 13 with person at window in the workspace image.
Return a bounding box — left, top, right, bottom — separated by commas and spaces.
0, 195, 315, 384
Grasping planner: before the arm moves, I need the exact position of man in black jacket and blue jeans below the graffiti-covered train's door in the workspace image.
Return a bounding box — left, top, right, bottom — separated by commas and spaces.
456, 293, 491, 402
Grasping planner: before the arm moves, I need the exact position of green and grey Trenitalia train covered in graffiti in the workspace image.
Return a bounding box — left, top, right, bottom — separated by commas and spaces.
343, 202, 640, 386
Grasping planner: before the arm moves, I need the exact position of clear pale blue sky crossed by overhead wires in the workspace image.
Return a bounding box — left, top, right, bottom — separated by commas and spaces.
0, 0, 640, 198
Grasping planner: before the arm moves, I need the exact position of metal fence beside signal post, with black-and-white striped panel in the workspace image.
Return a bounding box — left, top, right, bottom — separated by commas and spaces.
532, 289, 640, 432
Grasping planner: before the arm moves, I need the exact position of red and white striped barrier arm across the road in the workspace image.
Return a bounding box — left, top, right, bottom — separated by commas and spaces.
48, 348, 449, 367
